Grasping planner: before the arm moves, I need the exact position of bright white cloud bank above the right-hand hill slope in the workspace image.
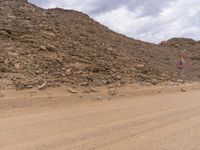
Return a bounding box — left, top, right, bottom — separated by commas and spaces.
95, 0, 200, 43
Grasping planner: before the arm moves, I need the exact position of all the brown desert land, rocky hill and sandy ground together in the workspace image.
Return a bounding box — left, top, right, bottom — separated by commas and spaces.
0, 0, 200, 150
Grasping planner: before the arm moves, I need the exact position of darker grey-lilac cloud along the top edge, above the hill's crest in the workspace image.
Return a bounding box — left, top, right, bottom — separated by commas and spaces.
30, 0, 172, 15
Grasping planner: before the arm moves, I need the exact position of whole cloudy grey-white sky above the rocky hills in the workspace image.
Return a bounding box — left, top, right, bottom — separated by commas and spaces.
29, 0, 200, 43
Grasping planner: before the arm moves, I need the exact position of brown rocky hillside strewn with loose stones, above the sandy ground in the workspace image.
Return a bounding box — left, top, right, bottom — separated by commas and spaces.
0, 0, 200, 89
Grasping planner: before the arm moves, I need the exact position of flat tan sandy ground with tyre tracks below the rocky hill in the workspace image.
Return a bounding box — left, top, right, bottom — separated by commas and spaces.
0, 84, 200, 150
